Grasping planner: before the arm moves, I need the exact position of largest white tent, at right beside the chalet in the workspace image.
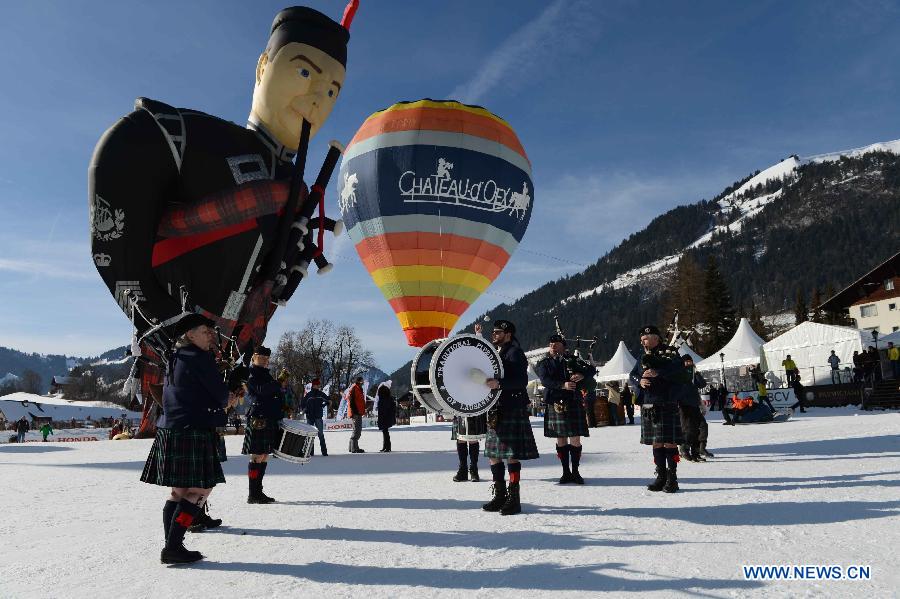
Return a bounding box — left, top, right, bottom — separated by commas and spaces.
763, 321, 881, 385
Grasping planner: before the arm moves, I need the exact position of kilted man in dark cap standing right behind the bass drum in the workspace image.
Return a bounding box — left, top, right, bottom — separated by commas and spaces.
481, 320, 538, 516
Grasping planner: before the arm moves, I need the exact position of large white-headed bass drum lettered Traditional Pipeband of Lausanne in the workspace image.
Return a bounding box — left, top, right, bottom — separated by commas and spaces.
410, 335, 503, 417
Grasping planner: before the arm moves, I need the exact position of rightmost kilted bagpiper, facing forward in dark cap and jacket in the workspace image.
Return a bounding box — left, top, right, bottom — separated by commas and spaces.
630, 325, 691, 493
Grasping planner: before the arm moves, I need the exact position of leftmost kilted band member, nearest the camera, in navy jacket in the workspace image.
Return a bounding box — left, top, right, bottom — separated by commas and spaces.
141, 314, 228, 564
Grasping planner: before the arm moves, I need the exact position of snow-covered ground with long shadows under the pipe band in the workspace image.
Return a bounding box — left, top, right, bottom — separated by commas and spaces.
0, 408, 900, 599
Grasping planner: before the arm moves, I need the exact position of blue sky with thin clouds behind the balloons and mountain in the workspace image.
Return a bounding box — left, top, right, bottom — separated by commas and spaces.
0, 0, 900, 371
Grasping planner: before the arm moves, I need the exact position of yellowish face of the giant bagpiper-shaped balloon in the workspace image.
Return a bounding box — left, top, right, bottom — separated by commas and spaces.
253, 42, 346, 148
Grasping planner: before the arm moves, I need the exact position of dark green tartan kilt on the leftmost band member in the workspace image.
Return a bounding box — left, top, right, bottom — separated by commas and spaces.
141, 428, 225, 489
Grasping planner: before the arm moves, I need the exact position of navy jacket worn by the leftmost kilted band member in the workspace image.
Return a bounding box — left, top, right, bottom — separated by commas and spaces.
157, 345, 228, 429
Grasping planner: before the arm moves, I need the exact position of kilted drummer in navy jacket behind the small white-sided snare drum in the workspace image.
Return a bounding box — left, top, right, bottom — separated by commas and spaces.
241, 345, 284, 503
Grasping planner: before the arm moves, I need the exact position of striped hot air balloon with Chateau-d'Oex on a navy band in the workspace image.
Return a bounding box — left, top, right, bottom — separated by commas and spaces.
338, 99, 534, 347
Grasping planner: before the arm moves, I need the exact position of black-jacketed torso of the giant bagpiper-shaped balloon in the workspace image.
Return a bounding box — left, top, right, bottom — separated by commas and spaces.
89, 98, 305, 347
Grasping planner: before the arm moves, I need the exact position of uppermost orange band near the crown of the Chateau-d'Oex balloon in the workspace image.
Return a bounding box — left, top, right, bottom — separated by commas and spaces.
347, 108, 528, 160
